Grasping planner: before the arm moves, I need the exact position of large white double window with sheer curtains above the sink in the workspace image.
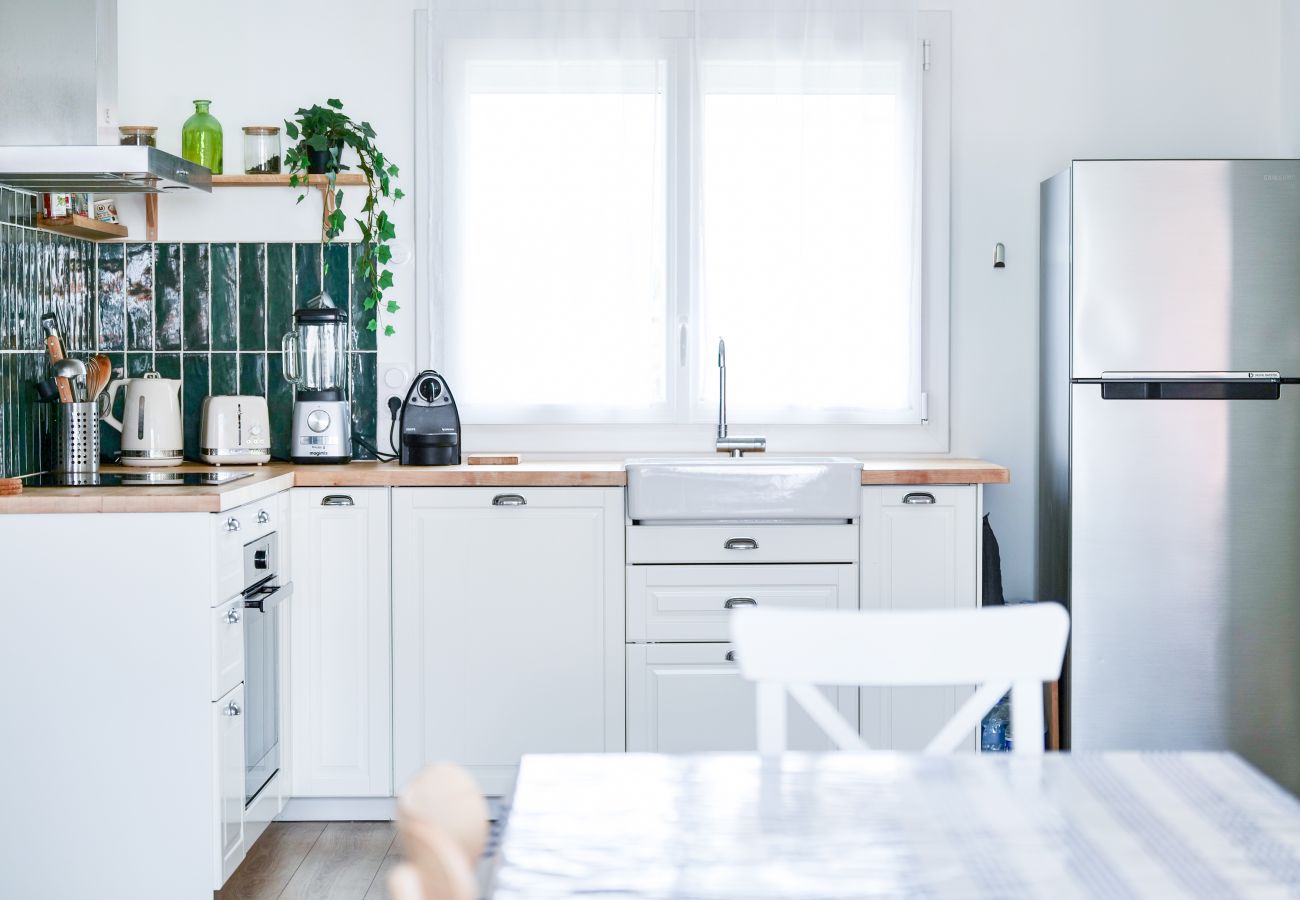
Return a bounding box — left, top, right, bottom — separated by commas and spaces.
417, 0, 948, 450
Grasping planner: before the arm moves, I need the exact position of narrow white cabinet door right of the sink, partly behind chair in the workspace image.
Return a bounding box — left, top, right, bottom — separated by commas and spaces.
861, 485, 980, 750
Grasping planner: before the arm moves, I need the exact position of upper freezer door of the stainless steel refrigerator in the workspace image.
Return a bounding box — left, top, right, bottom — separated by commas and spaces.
1071, 160, 1300, 378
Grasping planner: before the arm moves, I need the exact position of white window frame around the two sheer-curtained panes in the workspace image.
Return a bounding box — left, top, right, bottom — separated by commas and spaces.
415, 10, 952, 457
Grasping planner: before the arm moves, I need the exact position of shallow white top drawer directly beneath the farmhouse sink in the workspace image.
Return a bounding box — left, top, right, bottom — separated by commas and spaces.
628, 524, 858, 563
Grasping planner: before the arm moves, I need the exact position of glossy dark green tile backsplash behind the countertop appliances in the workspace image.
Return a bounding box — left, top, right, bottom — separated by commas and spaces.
0, 189, 377, 476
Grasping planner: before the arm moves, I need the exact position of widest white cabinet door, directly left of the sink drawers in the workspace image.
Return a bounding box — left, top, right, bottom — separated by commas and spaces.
393, 488, 624, 795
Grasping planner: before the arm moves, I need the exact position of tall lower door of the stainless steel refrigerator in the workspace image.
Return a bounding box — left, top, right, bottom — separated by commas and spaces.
1070, 384, 1300, 791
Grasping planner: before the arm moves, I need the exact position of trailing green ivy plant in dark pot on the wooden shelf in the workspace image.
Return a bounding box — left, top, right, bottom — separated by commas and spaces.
285, 98, 404, 336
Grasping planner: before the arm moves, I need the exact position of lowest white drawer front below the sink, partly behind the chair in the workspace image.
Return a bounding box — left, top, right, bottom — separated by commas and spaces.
628, 644, 858, 753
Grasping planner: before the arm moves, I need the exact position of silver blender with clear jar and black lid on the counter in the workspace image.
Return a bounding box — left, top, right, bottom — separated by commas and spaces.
281, 294, 352, 463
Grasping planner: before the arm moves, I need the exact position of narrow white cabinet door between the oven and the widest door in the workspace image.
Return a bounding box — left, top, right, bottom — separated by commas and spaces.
289, 488, 393, 797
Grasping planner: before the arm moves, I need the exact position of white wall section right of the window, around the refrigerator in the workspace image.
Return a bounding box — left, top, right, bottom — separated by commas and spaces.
924, 0, 1297, 597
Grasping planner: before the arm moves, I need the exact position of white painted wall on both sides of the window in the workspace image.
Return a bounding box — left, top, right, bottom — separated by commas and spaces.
118, 0, 1300, 597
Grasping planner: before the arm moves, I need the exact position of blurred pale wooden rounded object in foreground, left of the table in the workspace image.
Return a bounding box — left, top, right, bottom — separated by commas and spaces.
390, 762, 489, 900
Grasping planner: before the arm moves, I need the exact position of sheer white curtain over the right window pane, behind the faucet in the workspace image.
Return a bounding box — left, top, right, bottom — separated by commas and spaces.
694, 0, 922, 423
